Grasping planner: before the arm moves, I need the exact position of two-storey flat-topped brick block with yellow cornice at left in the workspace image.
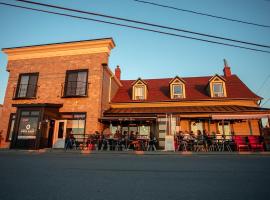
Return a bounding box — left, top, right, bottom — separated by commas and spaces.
0, 38, 121, 148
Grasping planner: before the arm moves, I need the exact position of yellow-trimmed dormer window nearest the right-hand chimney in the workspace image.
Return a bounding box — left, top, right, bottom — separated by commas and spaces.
209, 75, 227, 97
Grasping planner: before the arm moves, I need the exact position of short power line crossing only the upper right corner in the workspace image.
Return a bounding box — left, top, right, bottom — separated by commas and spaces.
134, 0, 270, 28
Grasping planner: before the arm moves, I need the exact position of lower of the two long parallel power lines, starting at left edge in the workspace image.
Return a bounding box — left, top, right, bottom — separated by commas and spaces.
0, 2, 270, 53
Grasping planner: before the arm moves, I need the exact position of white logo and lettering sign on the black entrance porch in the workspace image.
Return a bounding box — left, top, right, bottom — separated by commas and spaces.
18, 116, 38, 139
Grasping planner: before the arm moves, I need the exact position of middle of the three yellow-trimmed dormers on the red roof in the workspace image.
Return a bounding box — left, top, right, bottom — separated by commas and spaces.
170, 76, 186, 99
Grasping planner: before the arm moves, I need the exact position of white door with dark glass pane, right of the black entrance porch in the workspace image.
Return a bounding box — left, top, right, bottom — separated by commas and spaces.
53, 120, 67, 148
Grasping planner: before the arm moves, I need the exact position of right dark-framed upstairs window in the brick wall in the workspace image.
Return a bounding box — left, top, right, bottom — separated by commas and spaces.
64, 70, 88, 97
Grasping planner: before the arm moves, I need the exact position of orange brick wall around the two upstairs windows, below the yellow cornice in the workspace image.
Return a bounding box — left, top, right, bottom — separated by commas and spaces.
0, 53, 108, 146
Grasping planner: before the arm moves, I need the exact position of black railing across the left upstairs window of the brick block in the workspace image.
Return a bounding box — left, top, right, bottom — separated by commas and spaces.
13, 84, 39, 99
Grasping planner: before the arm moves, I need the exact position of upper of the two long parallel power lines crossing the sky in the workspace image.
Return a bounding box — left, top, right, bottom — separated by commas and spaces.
15, 0, 270, 48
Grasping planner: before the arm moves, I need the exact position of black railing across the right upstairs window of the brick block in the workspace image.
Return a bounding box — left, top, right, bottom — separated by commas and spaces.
61, 81, 89, 97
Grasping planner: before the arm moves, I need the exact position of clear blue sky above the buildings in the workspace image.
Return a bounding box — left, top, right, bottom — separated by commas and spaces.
0, 0, 270, 107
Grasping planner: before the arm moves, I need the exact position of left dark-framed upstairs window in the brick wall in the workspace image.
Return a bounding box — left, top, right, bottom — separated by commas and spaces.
16, 73, 38, 98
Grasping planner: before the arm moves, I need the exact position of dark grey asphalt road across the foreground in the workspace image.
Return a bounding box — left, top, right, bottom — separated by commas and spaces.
0, 152, 270, 200
